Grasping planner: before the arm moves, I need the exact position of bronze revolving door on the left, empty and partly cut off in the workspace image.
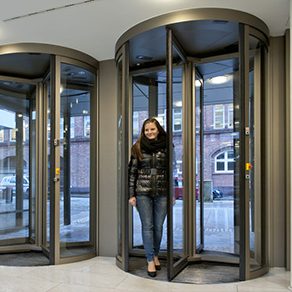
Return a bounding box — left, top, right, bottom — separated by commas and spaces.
0, 44, 98, 265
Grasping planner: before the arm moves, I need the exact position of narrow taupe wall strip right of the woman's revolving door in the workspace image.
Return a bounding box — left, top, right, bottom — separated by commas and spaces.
266, 37, 286, 267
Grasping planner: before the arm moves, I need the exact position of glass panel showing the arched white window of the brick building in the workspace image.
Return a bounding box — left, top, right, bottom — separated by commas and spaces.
197, 59, 238, 254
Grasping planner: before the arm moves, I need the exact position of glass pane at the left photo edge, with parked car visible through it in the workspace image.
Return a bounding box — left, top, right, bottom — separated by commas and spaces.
0, 80, 35, 245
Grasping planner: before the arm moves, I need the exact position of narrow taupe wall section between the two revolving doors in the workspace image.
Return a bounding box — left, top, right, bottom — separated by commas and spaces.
98, 60, 118, 256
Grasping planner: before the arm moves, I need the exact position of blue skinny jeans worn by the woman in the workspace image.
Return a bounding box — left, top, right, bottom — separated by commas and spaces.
136, 195, 167, 262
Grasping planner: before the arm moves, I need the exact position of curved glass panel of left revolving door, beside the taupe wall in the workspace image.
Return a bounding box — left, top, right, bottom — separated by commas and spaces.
60, 63, 95, 257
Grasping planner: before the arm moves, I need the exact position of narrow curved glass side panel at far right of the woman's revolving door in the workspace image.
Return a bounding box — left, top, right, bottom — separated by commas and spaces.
248, 36, 266, 271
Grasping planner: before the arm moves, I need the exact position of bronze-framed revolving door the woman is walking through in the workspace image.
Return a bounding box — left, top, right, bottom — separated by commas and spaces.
116, 9, 268, 280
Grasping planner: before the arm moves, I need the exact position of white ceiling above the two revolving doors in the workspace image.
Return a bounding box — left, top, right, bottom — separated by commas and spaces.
0, 0, 290, 61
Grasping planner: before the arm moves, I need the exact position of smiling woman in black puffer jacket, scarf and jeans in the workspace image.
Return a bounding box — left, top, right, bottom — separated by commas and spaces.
129, 118, 167, 277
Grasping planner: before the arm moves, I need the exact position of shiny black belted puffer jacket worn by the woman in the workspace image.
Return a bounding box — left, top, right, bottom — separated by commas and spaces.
129, 149, 167, 198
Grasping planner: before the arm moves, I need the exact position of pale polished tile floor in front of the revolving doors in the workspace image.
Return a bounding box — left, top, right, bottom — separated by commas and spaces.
0, 257, 290, 292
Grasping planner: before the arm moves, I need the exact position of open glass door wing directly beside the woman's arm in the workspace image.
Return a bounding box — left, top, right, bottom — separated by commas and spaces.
166, 29, 189, 280
